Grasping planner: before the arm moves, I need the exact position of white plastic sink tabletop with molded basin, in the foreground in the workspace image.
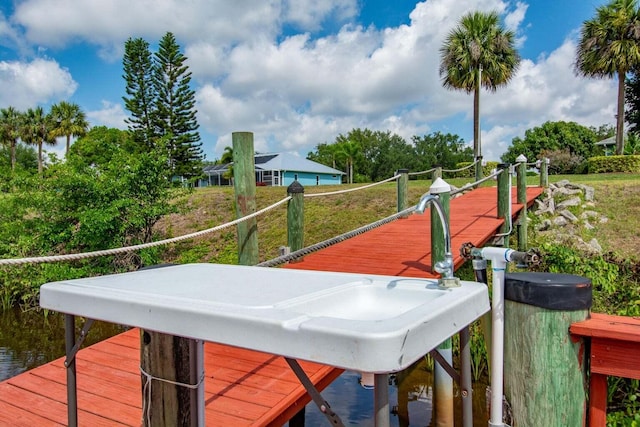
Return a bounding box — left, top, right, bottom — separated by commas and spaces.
40, 264, 489, 373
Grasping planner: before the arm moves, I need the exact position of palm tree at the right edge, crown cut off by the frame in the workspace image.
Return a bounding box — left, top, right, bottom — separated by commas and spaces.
576, 0, 640, 155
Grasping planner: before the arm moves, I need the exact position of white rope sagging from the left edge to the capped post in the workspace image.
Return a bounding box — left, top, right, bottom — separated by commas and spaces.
0, 196, 291, 265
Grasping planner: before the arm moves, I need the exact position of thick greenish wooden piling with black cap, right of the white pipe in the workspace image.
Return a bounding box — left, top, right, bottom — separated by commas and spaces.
504, 273, 591, 427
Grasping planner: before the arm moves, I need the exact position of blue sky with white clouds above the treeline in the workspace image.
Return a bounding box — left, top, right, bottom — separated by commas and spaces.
0, 0, 616, 164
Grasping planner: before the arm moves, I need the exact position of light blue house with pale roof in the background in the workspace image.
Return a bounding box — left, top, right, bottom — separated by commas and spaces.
198, 153, 344, 187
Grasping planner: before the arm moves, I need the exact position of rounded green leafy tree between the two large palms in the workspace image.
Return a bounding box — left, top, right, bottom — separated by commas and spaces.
501, 121, 599, 163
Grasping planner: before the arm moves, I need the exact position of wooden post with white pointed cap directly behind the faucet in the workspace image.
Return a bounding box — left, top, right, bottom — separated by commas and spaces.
429, 178, 454, 426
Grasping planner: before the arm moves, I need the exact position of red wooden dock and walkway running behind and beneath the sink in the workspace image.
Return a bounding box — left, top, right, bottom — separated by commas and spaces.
0, 187, 542, 427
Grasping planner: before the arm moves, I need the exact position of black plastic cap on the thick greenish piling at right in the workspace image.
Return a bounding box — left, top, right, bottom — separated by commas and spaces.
504, 273, 593, 310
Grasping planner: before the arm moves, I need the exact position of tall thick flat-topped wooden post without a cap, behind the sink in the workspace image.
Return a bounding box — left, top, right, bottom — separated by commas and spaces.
231, 132, 259, 265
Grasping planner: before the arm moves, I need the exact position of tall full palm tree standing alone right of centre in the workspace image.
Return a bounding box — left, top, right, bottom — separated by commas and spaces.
440, 12, 520, 178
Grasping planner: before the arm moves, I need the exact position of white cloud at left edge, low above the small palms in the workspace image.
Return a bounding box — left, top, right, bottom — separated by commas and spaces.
0, 58, 78, 110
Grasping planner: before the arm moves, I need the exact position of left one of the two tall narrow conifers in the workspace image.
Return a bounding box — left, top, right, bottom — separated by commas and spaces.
122, 38, 157, 150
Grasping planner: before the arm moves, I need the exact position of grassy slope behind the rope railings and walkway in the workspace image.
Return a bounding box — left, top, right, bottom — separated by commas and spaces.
157, 174, 640, 264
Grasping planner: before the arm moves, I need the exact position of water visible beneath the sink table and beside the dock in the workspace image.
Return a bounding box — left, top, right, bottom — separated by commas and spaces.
0, 309, 488, 427
